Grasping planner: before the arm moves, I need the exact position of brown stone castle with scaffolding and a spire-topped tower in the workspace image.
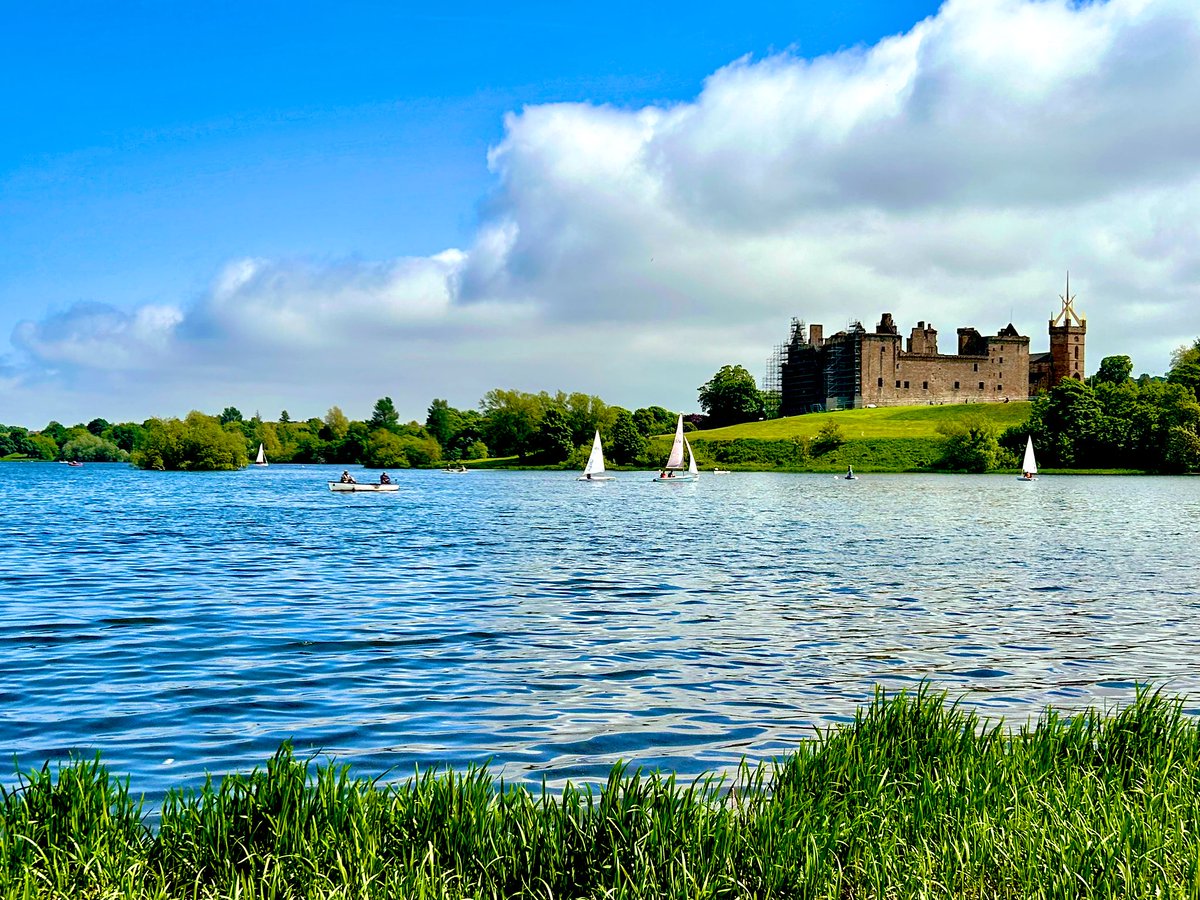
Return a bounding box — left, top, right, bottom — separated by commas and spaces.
779, 278, 1087, 415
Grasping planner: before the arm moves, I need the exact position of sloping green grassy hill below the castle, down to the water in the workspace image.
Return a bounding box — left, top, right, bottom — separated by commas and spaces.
654, 402, 1030, 472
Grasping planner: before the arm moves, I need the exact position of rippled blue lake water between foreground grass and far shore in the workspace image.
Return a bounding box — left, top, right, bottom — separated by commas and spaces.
0, 463, 1200, 803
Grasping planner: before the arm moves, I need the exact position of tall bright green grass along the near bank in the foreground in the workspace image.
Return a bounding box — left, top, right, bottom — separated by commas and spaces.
0, 690, 1200, 899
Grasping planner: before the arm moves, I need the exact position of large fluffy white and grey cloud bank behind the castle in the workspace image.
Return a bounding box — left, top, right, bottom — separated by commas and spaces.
7, 0, 1200, 427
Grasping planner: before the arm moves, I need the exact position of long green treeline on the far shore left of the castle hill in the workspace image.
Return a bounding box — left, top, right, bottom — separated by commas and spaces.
0, 389, 695, 470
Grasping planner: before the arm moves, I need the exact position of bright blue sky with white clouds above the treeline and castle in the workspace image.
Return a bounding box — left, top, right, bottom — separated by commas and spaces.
0, 0, 1200, 428
